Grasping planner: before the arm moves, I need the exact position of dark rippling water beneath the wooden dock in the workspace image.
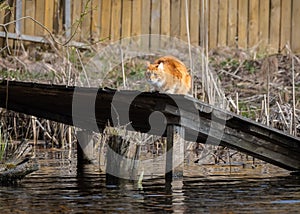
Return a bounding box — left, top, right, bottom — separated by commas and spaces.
0, 150, 300, 213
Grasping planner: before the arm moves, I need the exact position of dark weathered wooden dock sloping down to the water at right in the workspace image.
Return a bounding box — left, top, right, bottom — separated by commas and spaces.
0, 81, 300, 171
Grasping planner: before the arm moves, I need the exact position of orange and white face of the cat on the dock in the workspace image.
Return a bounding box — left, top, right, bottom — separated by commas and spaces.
145, 63, 165, 87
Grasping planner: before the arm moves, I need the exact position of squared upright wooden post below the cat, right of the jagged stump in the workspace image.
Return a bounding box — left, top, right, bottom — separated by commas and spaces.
165, 125, 184, 184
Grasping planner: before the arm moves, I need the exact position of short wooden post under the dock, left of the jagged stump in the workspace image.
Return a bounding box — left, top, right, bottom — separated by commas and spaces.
77, 130, 94, 165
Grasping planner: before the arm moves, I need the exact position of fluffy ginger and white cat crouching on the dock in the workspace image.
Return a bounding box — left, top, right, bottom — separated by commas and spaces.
145, 56, 191, 94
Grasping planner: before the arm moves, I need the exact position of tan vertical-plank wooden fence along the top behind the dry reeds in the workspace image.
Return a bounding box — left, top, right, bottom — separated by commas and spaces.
0, 0, 300, 52
